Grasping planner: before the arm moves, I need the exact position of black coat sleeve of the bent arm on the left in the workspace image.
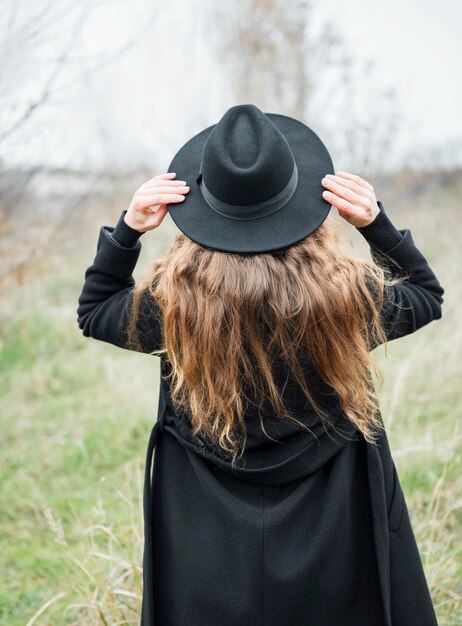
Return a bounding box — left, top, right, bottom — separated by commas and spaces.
77, 210, 162, 353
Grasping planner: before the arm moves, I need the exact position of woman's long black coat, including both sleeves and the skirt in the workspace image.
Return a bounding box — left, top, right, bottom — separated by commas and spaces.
77, 202, 444, 626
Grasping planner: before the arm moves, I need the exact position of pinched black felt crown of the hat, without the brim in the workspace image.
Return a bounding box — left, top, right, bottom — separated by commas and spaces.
201, 104, 295, 206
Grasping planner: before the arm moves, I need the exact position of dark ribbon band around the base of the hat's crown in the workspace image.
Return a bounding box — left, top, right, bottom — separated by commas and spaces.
199, 159, 298, 220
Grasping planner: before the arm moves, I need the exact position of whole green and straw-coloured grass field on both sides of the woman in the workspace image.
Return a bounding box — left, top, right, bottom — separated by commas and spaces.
0, 178, 462, 626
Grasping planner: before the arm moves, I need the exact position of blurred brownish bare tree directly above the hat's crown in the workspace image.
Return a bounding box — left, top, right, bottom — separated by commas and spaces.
209, 0, 311, 117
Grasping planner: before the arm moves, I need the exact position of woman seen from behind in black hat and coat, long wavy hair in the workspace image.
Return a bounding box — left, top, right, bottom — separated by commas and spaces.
77, 104, 444, 626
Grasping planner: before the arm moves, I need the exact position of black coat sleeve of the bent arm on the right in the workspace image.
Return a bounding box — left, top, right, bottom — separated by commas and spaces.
357, 201, 444, 349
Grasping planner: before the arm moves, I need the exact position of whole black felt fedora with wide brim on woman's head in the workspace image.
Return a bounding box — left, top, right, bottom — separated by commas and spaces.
168, 104, 335, 253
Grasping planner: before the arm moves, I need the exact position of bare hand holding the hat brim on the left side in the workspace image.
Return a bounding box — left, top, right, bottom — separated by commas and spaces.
124, 172, 189, 233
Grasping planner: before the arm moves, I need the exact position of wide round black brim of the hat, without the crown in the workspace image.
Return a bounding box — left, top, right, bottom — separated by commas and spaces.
168, 113, 335, 253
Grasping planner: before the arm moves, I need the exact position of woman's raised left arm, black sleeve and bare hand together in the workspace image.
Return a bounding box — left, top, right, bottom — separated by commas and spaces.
77, 172, 189, 353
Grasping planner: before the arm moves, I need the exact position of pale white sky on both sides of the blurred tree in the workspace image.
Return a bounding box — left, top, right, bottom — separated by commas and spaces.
0, 0, 462, 169
